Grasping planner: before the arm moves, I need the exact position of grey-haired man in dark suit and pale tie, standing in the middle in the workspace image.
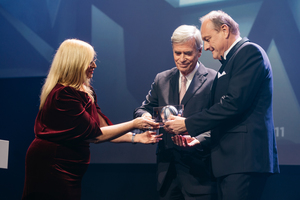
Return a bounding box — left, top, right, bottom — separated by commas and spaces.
134, 25, 217, 200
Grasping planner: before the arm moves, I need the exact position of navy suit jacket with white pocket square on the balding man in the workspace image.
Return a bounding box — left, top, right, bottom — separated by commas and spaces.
185, 38, 279, 177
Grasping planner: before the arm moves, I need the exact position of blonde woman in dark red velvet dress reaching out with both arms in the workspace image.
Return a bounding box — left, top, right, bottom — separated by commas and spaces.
22, 39, 161, 200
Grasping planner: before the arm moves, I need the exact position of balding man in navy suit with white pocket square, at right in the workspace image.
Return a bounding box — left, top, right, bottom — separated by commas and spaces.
165, 11, 279, 200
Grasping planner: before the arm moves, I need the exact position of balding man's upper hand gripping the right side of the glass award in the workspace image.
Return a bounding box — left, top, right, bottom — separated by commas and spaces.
164, 115, 187, 135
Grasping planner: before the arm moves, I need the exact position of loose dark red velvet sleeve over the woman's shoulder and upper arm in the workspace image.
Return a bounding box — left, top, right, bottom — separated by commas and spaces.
35, 86, 102, 142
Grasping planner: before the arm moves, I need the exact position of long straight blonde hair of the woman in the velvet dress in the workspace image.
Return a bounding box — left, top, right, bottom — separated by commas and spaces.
40, 39, 96, 110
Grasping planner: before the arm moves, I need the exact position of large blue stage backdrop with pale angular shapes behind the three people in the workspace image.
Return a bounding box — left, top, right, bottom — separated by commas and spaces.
0, 0, 300, 167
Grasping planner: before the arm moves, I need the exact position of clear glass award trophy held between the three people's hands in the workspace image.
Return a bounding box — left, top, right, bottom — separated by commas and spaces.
152, 105, 183, 127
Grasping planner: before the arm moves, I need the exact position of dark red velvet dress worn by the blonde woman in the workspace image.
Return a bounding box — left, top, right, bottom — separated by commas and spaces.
22, 84, 111, 200
